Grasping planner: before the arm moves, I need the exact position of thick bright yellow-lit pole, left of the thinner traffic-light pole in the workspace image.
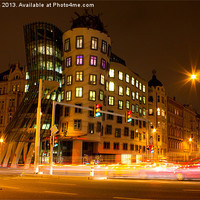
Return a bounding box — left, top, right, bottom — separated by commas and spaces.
34, 79, 42, 174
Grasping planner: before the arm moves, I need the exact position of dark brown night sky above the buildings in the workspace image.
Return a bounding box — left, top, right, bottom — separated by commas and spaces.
0, 0, 200, 112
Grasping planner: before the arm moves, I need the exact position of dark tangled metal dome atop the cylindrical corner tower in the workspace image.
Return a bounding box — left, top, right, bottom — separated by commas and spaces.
71, 12, 107, 34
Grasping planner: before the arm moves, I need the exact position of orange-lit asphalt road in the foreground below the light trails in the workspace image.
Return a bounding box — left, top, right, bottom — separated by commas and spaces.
0, 173, 200, 200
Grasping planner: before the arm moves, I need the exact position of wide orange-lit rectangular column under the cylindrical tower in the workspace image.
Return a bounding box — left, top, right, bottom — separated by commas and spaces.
72, 140, 83, 164
